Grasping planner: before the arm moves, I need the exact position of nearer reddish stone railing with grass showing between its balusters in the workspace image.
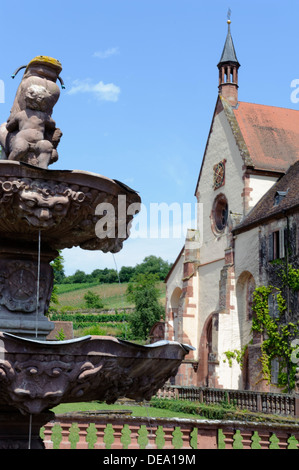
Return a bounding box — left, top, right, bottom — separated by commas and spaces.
42, 414, 299, 449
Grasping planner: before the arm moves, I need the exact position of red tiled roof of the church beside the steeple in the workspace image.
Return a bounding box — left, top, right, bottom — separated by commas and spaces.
233, 102, 299, 173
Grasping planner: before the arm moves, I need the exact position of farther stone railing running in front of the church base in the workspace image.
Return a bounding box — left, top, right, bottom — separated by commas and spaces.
157, 385, 299, 417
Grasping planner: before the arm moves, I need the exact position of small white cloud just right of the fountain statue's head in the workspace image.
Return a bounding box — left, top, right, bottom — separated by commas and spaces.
68, 79, 120, 101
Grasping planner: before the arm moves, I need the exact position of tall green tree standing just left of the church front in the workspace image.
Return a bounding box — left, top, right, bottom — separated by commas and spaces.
127, 274, 165, 340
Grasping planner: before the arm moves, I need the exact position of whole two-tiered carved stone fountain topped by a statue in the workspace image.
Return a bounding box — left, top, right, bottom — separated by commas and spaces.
0, 56, 191, 449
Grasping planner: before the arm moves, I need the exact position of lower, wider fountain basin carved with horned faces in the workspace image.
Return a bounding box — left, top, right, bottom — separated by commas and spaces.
0, 332, 193, 415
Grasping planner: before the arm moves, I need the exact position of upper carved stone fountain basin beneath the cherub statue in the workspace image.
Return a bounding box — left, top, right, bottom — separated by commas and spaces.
0, 160, 141, 253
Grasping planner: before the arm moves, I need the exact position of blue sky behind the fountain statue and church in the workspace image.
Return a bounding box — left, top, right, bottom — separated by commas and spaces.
0, 0, 299, 275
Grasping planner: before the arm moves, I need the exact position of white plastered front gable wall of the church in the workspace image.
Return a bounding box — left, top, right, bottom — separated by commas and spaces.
198, 106, 244, 388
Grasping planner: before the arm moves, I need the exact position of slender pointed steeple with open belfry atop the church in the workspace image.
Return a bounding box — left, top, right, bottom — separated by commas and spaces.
217, 18, 240, 106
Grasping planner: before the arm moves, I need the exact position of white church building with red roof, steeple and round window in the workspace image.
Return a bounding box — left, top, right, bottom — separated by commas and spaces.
165, 20, 299, 391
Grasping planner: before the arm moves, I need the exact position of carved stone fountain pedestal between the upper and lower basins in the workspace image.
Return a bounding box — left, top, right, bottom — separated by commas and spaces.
0, 240, 58, 339
